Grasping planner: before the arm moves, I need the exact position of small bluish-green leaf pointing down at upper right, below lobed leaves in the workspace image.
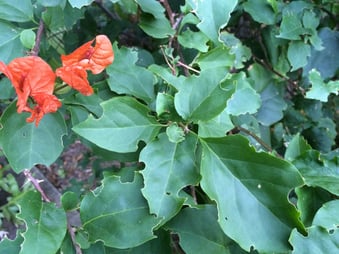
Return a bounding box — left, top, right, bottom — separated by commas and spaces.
287, 41, 311, 71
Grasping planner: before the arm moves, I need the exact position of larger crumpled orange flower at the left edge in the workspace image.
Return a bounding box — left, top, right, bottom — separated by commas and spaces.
0, 56, 61, 126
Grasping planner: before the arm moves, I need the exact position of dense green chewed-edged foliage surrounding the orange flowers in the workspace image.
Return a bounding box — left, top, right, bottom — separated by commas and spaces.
0, 0, 339, 254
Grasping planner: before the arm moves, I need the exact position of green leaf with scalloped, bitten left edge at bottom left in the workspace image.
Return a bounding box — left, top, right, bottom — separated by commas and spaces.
18, 191, 67, 254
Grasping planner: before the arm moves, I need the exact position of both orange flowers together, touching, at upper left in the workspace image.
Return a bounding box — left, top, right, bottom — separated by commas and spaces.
0, 35, 114, 126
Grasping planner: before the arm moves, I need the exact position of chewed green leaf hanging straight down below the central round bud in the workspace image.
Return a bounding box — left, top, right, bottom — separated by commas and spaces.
140, 134, 199, 223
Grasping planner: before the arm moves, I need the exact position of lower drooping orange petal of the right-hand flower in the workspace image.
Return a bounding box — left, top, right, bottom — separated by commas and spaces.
56, 65, 93, 95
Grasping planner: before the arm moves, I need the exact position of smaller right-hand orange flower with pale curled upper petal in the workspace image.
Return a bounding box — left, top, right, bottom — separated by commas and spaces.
56, 35, 114, 95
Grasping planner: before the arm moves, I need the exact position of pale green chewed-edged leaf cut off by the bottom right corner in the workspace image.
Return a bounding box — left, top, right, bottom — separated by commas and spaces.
289, 226, 339, 254
